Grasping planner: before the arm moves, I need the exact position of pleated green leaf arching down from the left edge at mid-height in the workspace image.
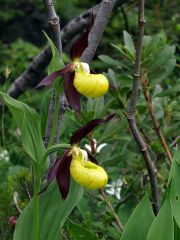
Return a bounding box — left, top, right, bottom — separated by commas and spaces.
0, 92, 45, 162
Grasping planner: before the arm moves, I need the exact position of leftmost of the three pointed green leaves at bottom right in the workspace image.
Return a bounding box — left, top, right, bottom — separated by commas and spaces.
121, 195, 155, 240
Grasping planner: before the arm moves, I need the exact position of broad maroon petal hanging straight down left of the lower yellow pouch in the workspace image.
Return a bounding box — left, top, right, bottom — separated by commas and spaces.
56, 150, 72, 200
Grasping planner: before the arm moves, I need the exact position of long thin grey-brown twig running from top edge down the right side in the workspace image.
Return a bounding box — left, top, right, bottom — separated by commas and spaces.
127, 0, 159, 214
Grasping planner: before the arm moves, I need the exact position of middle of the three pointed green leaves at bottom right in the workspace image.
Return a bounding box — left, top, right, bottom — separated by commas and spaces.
147, 198, 174, 240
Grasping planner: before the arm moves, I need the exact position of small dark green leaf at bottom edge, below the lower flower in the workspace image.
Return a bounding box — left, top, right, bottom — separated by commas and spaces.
68, 220, 98, 240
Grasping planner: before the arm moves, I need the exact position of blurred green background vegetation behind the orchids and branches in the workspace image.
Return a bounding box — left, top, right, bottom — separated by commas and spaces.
0, 0, 180, 240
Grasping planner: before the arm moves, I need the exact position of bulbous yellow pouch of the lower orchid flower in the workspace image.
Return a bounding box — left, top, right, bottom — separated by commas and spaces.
70, 147, 108, 189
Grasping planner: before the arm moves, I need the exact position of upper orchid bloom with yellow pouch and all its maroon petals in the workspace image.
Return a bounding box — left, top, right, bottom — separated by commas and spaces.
36, 15, 109, 115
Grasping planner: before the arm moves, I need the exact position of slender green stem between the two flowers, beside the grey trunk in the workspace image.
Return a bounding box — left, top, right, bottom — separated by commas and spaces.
48, 92, 59, 148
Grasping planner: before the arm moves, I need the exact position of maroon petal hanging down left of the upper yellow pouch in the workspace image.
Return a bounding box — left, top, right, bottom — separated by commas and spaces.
64, 72, 81, 114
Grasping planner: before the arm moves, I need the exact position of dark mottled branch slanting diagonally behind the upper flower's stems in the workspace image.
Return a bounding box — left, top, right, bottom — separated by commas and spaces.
7, 0, 128, 98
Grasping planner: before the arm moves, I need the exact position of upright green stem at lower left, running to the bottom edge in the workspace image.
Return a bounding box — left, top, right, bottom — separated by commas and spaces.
33, 176, 40, 240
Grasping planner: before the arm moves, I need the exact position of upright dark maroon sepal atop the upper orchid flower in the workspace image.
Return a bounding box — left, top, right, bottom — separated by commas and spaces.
70, 14, 94, 60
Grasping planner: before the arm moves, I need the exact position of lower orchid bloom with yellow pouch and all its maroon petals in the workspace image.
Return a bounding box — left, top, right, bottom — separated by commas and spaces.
45, 114, 115, 199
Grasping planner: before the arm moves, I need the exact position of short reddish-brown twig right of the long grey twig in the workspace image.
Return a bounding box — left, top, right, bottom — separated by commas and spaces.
141, 77, 173, 164
